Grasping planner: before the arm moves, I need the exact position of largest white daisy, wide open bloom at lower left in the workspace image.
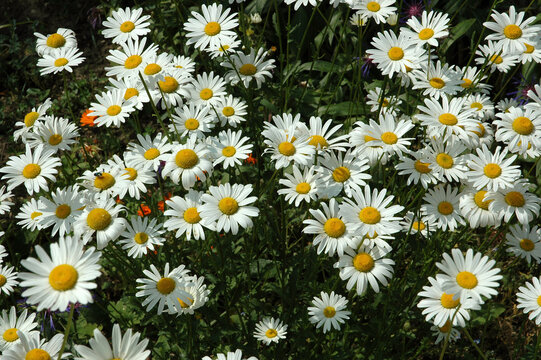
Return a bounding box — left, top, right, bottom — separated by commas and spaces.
19, 236, 101, 311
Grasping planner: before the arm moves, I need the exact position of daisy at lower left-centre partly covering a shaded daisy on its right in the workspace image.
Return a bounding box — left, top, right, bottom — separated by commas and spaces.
135, 263, 190, 315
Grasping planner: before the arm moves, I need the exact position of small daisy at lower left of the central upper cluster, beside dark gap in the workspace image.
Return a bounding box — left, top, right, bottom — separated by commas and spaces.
278, 165, 319, 207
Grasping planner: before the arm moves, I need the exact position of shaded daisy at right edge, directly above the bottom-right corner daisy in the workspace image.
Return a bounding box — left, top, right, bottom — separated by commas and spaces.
505, 224, 541, 264
